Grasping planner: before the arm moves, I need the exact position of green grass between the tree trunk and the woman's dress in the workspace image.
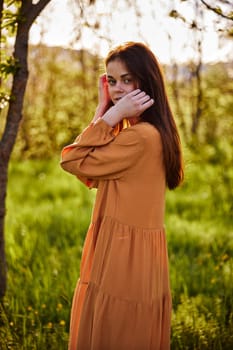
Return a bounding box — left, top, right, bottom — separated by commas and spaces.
0, 160, 94, 350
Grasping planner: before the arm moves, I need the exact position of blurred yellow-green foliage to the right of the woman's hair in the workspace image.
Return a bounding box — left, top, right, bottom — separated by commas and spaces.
165, 62, 233, 149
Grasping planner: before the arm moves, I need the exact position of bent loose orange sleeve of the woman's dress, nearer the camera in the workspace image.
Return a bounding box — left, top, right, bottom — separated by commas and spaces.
61, 119, 143, 180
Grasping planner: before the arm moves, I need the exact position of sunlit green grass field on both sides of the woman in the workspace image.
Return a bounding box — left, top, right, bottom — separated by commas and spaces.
0, 151, 233, 350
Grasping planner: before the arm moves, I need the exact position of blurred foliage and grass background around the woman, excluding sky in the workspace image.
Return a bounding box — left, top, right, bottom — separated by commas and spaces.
0, 1, 233, 350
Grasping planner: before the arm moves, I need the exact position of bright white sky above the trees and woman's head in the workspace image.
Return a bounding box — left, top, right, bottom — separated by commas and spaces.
30, 0, 233, 63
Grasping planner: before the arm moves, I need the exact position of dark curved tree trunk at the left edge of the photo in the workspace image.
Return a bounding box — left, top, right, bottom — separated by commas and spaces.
0, 0, 51, 298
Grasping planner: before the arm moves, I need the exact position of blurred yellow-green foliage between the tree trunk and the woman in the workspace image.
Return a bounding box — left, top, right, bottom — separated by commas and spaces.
10, 46, 99, 158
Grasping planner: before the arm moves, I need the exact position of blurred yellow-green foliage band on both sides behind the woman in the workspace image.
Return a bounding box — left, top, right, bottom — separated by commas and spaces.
0, 46, 233, 159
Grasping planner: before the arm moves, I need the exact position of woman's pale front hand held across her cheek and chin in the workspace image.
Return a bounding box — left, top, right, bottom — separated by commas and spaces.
103, 89, 154, 126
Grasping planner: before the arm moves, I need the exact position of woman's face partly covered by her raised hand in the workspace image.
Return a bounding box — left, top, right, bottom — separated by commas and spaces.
106, 59, 139, 104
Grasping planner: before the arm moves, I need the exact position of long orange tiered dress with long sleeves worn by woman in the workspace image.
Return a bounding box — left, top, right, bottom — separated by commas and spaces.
61, 119, 172, 350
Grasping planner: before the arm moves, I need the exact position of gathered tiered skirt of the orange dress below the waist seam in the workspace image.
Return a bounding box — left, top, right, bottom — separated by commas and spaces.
70, 217, 171, 350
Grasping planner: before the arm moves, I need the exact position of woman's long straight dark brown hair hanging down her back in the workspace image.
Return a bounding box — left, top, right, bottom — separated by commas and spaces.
105, 42, 184, 189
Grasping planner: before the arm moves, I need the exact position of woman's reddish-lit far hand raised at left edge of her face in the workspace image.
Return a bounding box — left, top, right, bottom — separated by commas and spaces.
93, 74, 112, 122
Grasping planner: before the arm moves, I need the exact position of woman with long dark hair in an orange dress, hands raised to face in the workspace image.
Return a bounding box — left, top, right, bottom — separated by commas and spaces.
61, 42, 183, 350
